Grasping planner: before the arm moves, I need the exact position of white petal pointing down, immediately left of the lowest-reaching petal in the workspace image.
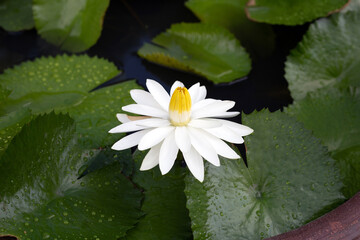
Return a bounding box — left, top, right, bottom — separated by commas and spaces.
159, 132, 179, 175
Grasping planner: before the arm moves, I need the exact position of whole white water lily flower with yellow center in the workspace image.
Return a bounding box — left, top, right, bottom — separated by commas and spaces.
109, 79, 253, 182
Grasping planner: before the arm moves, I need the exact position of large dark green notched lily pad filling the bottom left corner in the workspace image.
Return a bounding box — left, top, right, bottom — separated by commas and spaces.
0, 113, 141, 240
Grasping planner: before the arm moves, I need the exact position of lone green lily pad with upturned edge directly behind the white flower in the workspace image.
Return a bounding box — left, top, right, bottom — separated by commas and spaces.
138, 23, 251, 83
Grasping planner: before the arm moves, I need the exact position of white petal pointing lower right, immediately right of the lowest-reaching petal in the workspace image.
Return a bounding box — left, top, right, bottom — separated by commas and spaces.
188, 127, 220, 166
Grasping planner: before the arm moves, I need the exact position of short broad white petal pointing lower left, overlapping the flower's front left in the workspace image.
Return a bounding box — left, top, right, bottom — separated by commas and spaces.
138, 126, 175, 151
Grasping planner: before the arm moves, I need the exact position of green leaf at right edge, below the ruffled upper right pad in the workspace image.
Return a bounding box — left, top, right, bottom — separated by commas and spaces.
286, 88, 360, 198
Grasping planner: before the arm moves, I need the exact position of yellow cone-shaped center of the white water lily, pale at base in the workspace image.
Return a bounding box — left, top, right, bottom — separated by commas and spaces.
169, 87, 191, 126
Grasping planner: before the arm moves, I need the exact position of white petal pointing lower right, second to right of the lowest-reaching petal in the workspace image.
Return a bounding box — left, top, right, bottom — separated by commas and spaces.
188, 126, 240, 159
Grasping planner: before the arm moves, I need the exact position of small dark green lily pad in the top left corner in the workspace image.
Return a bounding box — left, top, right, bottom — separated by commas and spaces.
0, 0, 34, 32
